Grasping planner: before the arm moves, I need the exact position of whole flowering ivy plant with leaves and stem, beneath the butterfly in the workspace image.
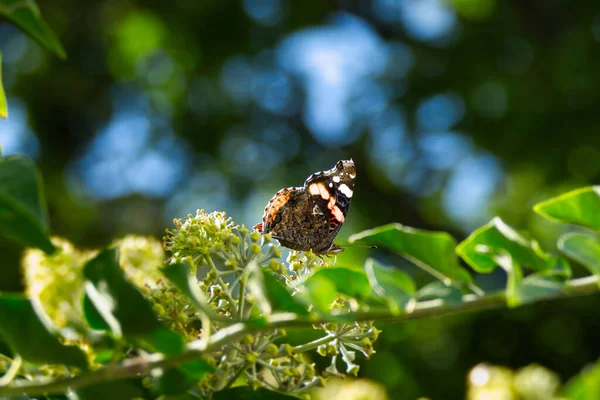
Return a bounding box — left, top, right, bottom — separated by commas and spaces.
0, 152, 600, 399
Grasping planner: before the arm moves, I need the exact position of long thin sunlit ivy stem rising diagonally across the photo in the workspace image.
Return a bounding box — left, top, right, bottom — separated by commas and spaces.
0, 276, 600, 398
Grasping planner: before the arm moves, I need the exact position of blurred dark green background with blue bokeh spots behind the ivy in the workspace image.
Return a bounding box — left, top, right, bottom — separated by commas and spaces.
0, 0, 600, 399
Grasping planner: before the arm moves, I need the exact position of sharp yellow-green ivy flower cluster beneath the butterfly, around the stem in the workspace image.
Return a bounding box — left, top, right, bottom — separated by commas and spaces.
160, 210, 379, 395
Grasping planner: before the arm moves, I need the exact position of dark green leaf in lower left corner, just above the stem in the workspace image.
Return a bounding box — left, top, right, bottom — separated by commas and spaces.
0, 293, 88, 369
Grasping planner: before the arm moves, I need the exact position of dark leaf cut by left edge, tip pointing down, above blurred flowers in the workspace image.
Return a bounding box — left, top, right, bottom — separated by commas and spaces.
0, 155, 55, 254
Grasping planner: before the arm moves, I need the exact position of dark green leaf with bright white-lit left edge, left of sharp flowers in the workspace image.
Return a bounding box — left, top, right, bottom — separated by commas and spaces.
84, 248, 184, 354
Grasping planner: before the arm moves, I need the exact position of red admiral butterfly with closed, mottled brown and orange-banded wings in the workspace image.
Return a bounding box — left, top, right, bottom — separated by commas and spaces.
254, 160, 356, 254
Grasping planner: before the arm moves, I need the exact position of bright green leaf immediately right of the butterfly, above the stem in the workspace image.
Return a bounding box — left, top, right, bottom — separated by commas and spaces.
349, 224, 472, 285
